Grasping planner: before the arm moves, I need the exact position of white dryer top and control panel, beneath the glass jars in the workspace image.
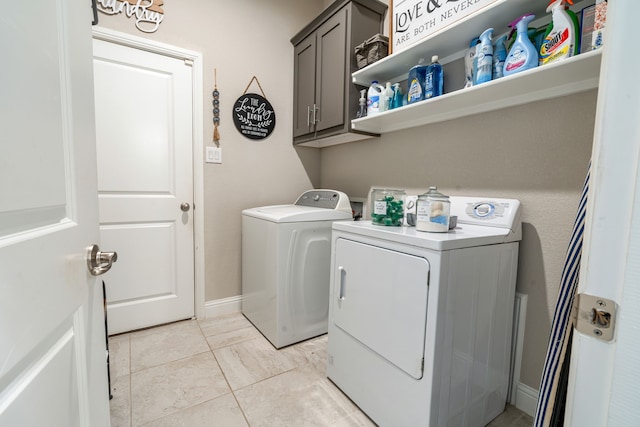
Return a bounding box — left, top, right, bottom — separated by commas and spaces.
333, 196, 522, 251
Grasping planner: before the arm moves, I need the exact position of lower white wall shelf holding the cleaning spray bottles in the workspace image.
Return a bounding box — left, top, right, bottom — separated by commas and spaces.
352, 49, 602, 134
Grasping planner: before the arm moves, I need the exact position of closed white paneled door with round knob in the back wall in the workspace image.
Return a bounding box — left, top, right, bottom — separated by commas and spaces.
93, 39, 194, 333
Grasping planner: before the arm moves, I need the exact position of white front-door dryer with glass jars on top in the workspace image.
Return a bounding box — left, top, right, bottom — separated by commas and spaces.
327, 197, 522, 427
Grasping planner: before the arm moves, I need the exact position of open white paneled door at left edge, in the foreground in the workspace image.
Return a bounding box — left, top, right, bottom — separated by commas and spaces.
0, 0, 109, 427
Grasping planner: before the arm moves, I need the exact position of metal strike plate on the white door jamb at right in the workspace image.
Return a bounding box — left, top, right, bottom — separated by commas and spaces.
572, 294, 616, 341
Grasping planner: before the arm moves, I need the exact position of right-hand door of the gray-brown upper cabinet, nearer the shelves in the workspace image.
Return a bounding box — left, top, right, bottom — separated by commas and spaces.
316, 8, 347, 132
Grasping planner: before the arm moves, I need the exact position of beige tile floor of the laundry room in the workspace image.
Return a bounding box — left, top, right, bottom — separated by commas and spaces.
109, 313, 532, 427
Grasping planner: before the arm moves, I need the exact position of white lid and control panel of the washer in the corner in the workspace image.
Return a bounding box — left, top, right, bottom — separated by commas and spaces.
242, 189, 353, 222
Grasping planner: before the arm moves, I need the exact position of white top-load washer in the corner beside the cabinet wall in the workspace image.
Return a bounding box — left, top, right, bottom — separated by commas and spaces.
242, 190, 352, 348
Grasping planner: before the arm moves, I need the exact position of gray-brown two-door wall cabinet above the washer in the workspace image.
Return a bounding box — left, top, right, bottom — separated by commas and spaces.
291, 0, 387, 147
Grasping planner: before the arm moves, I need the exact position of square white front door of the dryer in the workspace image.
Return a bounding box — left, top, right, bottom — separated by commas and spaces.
332, 238, 429, 379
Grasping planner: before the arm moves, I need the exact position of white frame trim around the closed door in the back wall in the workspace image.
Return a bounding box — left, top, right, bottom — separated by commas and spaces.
93, 27, 205, 319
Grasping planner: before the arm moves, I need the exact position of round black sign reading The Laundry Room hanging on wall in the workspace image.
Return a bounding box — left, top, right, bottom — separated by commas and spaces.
233, 93, 276, 139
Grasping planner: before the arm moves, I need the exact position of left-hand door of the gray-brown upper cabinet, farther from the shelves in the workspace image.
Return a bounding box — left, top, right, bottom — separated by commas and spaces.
293, 33, 316, 137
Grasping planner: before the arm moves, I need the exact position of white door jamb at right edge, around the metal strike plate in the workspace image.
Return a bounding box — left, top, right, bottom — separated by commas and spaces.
565, 0, 640, 427
